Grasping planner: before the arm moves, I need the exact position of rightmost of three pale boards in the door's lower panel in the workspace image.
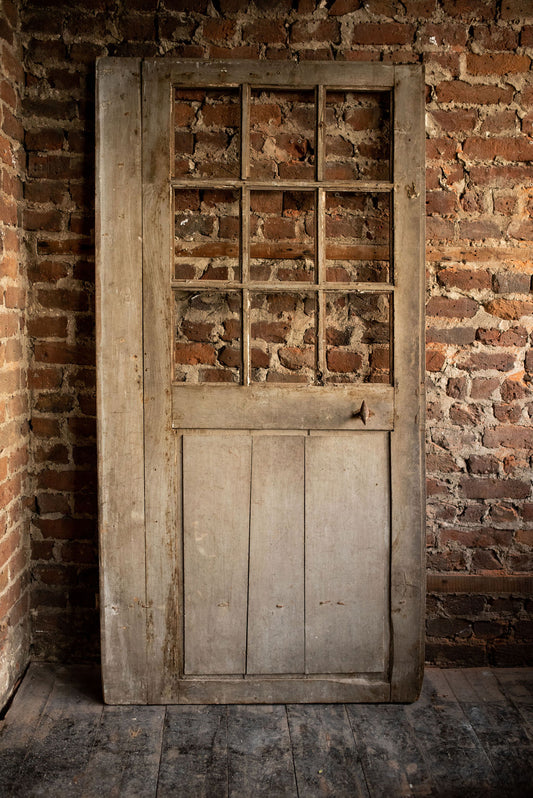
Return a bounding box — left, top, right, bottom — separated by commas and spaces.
305, 432, 390, 673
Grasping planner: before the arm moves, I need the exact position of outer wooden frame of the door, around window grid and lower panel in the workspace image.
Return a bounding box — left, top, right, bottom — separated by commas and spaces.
96, 58, 425, 704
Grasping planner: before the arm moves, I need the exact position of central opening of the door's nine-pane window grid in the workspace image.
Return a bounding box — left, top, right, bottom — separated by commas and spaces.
250, 191, 316, 283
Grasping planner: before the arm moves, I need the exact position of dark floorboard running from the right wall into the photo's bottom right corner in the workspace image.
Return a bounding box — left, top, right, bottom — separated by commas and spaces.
444, 668, 533, 798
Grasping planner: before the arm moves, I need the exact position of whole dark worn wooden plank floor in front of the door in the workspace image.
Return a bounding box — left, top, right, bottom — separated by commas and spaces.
0, 664, 533, 798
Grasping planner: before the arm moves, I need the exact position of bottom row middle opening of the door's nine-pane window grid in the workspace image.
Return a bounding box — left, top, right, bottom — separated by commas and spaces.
250, 291, 317, 384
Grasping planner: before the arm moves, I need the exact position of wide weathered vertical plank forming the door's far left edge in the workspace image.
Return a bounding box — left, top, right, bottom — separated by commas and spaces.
96, 58, 147, 703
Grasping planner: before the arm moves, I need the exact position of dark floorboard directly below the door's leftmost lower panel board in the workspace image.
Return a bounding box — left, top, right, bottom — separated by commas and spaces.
157, 706, 228, 798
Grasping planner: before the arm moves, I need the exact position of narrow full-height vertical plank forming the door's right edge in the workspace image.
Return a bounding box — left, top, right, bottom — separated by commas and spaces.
391, 66, 425, 701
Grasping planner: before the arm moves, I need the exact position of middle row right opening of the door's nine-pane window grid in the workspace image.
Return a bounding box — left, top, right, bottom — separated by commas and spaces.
326, 191, 392, 283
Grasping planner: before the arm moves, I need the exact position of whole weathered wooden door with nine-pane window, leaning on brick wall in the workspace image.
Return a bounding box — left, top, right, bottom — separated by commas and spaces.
98, 59, 424, 703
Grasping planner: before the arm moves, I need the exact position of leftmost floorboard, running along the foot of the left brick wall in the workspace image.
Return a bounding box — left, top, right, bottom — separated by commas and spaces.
0, 663, 56, 795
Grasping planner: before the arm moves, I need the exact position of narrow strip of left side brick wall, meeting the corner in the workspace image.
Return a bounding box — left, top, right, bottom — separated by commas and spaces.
0, 0, 29, 707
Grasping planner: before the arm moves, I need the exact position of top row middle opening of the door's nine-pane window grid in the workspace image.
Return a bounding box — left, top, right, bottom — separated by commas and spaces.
250, 89, 316, 180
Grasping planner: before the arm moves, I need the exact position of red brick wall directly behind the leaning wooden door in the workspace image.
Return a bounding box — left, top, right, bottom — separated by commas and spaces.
13, 0, 533, 664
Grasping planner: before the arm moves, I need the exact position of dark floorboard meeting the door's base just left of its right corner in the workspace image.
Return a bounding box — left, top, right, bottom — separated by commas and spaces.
346, 704, 432, 798
